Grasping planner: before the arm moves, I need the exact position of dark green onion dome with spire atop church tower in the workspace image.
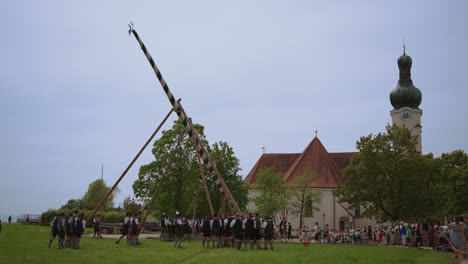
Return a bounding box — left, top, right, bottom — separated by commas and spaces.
390, 46, 422, 109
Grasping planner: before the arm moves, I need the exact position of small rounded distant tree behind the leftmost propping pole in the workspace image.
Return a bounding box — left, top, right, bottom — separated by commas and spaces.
81, 179, 119, 210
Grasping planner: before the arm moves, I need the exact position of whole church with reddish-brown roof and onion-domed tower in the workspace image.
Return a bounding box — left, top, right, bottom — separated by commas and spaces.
244, 49, 422, 231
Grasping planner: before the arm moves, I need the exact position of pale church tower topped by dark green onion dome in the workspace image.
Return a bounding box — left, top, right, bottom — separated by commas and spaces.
390, 46, 422, 152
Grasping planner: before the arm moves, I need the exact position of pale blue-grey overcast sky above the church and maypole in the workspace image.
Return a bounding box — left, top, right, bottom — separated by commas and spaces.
0, 0, 468, 219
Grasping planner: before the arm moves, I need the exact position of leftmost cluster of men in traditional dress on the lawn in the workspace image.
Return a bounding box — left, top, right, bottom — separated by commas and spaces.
49, 210, 86, 249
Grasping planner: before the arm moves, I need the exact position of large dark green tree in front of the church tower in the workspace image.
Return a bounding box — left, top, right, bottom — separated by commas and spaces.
335, 126, 428, 221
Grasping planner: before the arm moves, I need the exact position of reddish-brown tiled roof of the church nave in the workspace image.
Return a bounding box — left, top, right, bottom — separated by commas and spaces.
244, 137, 357, 188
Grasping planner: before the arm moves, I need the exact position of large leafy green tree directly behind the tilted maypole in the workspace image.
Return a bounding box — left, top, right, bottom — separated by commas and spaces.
133, 120, 247, 217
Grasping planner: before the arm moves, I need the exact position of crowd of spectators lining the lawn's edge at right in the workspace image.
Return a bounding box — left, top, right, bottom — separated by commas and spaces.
297, 217, 468, 258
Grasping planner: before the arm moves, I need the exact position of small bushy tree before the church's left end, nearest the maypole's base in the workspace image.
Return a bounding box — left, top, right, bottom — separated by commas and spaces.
253, 167, 284, 218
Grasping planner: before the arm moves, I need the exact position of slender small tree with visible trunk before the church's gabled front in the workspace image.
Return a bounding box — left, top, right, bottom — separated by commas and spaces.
287, 169, 322, 227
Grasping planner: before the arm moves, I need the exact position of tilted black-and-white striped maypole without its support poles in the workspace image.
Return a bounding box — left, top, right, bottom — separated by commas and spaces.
128, 22, 240, 213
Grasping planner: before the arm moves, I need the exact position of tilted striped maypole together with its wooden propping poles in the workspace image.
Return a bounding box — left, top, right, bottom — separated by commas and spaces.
87, 23, 240, 229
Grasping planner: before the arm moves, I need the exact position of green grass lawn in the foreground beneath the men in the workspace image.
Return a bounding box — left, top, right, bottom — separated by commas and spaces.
0, 224, 456, 264
